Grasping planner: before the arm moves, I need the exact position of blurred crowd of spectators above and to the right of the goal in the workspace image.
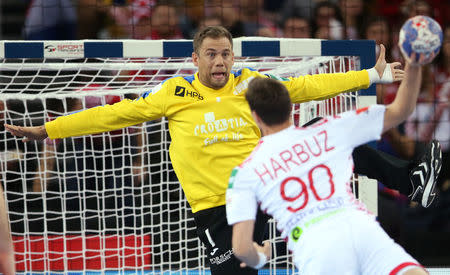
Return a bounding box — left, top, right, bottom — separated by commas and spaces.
0, 0, 450, 268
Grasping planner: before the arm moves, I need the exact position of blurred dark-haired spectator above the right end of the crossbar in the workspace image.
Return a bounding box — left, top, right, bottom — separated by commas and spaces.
311, 1, 344, 40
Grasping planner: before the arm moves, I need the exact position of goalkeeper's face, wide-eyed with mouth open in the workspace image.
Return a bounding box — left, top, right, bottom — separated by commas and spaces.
192, 37, 234, 89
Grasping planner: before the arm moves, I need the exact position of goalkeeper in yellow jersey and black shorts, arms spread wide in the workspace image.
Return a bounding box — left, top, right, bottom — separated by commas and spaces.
1, 27, 440, 275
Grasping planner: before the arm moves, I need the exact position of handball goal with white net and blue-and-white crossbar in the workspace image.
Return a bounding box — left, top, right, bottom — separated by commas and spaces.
0, 39, 376, 274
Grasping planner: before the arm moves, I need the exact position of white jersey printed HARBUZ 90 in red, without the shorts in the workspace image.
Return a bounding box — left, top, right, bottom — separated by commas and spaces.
227, 105, 385, 242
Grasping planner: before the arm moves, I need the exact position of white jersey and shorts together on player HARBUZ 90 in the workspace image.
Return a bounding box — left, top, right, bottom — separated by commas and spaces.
226, 105, 420, 275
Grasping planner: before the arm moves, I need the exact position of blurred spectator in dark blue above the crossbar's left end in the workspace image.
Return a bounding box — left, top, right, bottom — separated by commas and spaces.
23, 0, 77, 40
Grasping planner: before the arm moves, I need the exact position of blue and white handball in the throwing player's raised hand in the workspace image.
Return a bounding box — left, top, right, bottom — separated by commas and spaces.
398, 15, 443, 63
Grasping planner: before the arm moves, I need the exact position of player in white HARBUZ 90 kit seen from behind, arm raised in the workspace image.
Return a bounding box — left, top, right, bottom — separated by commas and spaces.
226, 52, 440, 275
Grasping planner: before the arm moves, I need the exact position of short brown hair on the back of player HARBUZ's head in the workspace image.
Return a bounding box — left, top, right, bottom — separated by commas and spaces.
245, 77, 292, 126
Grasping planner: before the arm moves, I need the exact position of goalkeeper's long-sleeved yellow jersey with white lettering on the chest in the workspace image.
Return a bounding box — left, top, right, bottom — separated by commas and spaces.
45, 68, 369, 212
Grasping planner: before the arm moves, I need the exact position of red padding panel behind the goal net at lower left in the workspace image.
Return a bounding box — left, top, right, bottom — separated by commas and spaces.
13, 235, 151, 271
